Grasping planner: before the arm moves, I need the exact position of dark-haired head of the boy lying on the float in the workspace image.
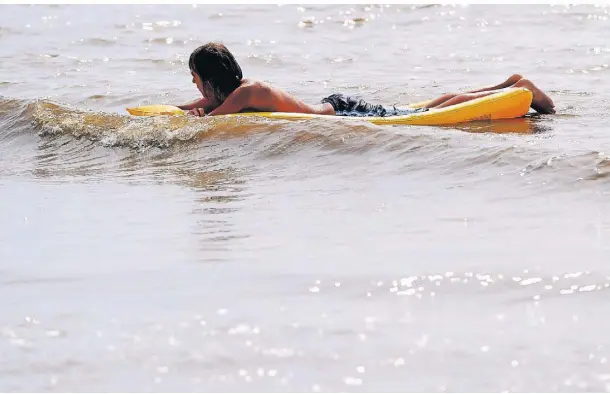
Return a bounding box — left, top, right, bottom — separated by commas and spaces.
189, 42, 243, 104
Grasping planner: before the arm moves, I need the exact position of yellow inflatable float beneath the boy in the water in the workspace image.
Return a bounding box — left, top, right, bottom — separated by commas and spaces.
127, 88, 533, 126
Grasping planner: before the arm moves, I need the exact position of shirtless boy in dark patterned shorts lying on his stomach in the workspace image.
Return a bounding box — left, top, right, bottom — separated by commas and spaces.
178, 43, 555, 116
